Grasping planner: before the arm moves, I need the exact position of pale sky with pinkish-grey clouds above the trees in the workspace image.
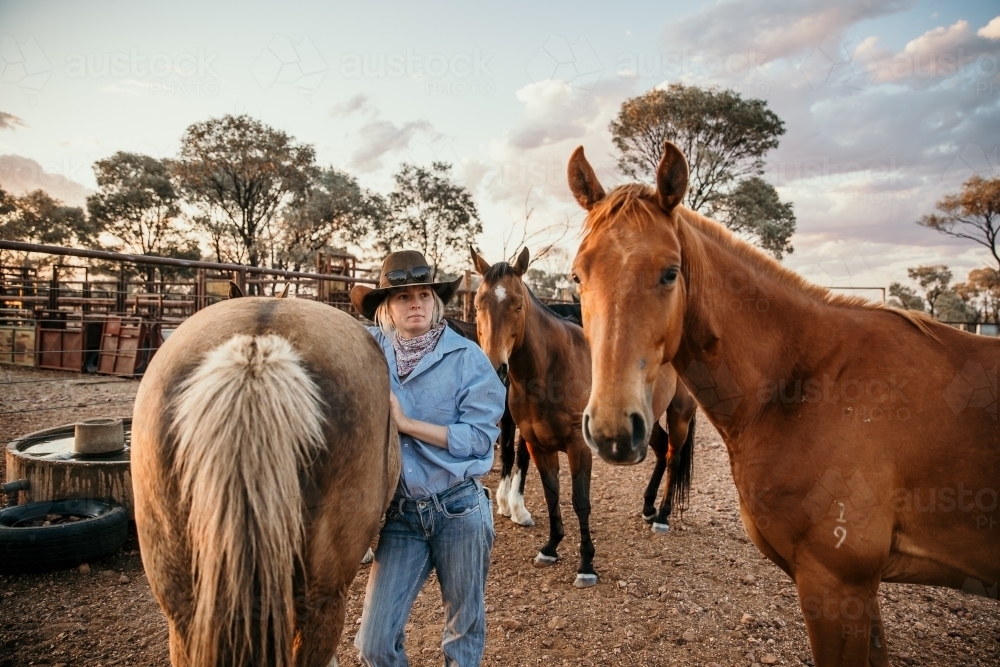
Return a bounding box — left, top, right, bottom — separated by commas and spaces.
0, 0, 1000, 297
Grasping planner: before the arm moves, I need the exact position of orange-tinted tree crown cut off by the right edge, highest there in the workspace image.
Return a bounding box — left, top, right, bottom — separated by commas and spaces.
917, 176, 1000, 269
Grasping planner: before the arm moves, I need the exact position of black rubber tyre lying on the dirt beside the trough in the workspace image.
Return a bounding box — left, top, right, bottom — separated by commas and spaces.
0, 498, 128, 574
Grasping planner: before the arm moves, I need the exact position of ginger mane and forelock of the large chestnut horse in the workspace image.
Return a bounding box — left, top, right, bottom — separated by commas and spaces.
583, 183, 940, 342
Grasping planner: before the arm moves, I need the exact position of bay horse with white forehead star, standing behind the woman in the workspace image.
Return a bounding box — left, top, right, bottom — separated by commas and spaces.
472, 248, 694, 588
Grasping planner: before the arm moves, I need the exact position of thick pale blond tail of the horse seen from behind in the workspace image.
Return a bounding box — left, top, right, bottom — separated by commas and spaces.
172, 334, 325, 667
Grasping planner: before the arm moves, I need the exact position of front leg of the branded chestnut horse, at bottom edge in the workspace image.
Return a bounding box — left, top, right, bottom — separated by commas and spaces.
795, 564, 889, 667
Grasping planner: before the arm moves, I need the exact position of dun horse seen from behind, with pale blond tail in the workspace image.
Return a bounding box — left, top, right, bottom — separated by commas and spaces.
132, 297, 400, 667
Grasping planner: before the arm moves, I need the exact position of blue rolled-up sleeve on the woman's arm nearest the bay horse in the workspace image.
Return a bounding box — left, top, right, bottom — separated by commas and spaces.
448, 354, 507, 458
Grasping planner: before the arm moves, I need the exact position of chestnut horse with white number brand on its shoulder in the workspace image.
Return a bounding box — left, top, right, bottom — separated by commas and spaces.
568, 142, 1000, 667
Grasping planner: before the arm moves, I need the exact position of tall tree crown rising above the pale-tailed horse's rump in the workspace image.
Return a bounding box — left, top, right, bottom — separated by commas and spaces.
172, 115, 316, 266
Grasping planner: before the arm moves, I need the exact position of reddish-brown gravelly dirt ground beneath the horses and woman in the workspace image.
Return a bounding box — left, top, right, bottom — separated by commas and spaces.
0, 366, 1000, 667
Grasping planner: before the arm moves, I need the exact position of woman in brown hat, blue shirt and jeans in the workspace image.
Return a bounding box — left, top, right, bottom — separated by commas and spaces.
351, 250, 505, 667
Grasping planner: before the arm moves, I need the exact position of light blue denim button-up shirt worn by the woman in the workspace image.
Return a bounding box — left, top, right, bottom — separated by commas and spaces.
368, 327, 506, 499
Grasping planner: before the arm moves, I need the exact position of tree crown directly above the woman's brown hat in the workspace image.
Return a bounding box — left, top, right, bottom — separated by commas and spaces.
373, 162, 483, 279
